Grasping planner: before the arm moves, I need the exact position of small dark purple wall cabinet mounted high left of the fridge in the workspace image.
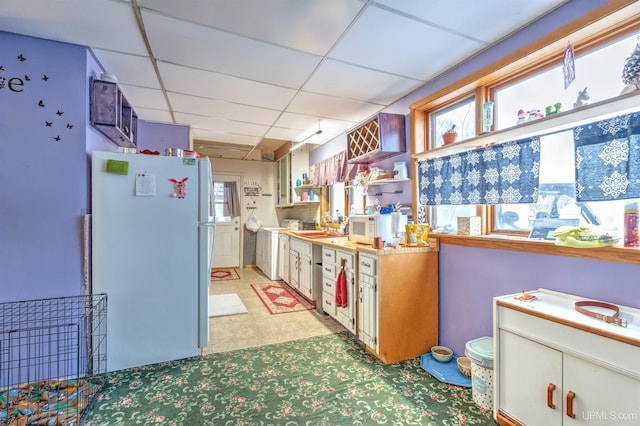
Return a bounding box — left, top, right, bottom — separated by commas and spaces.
89, 78, 138, 148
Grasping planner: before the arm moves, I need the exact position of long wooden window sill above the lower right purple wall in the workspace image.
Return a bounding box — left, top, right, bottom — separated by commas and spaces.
430, 234, 640, 264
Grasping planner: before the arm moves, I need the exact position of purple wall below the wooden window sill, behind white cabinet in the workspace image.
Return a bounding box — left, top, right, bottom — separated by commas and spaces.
439, 244, 640, 356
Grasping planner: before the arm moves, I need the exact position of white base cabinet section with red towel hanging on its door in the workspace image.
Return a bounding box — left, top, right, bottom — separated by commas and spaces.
318, 247, 357, 334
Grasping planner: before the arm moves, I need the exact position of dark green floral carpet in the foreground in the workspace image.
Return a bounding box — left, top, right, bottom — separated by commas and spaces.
86, 333, 495, 426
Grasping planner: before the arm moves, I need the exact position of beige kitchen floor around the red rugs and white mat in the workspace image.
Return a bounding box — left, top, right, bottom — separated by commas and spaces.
202, 268, 344, 355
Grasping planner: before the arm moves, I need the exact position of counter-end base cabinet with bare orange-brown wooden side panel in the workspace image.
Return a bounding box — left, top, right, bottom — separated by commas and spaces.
357, 238, 438, 364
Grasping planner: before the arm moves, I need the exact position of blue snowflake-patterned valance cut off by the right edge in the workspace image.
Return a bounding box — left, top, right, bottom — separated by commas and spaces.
573, 112, 640, 201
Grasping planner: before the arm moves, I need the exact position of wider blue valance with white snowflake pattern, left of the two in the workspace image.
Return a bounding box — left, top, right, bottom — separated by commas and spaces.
418, 137, 540, 205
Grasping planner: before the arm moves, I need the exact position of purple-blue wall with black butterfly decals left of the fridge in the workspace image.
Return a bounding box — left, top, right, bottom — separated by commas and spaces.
0, 32, 95, 301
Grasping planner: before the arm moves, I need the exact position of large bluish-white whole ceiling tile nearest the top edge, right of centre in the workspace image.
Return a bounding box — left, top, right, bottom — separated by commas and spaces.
329, 7, 485, 81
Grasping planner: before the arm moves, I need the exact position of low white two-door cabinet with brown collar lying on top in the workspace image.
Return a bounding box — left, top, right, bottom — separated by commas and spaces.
494, 290, 640, 425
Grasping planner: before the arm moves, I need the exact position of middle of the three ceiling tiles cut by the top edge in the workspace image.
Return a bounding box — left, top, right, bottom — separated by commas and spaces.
138, 0, 363, 55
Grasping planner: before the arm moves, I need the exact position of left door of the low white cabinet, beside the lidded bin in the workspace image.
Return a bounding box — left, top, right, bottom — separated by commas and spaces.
494, 330, 563, 426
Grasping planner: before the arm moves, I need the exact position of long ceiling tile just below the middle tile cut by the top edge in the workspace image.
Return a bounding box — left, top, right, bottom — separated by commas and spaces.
143, 12, 321, 89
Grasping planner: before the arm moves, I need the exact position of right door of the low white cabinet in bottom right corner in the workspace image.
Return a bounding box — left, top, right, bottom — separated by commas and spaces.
561, 354, 640, 425
